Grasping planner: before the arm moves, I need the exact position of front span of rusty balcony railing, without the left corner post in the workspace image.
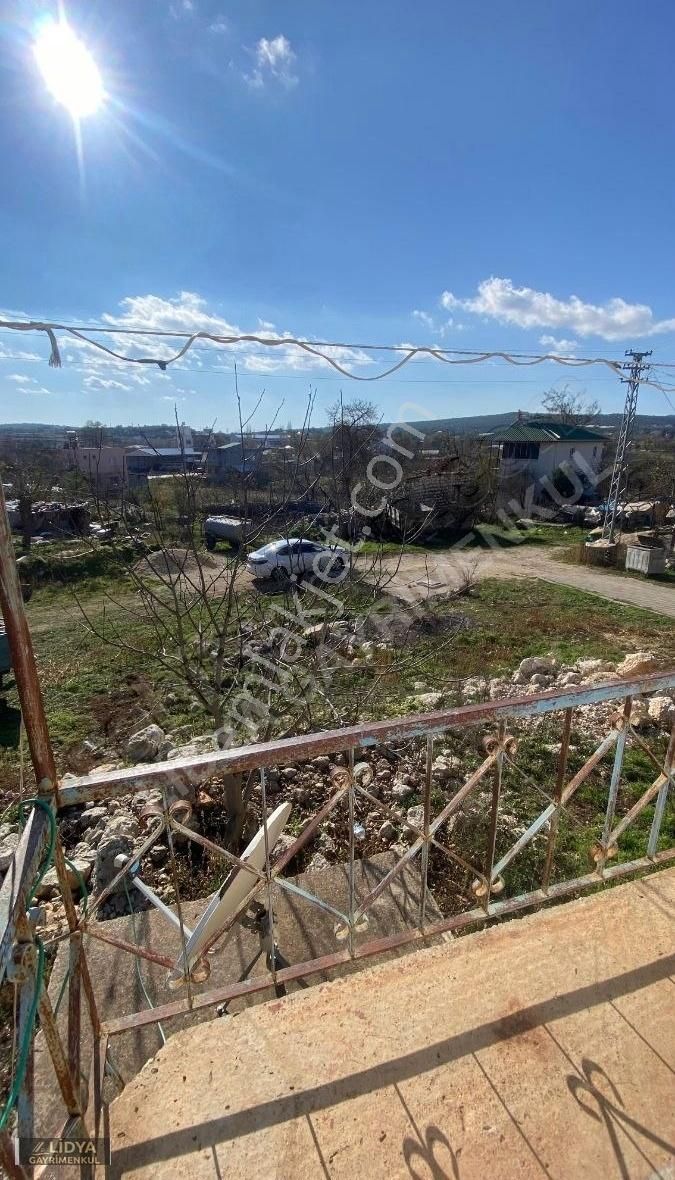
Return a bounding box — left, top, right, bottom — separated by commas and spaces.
60, 671, 675, 1035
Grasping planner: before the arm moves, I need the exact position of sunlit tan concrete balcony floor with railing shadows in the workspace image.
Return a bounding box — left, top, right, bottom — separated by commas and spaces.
110, 870, 675, 1180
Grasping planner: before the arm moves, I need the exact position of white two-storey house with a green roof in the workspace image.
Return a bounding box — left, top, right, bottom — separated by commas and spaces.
487, 414, 607, 483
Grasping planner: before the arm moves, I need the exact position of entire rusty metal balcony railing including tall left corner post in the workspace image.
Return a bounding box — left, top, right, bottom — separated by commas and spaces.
0, 474, 675, 1176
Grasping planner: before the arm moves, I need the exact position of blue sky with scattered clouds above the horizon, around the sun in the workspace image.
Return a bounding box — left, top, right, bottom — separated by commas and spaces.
0, 0, 675, 428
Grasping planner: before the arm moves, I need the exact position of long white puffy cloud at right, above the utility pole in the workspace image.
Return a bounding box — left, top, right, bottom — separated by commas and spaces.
440, 277, 675, 340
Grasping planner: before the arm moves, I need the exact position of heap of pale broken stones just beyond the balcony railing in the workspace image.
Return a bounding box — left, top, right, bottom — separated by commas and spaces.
0, 651, 675, 925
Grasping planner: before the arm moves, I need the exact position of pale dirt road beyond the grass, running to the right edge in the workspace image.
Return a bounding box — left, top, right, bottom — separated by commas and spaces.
382, 545, 675, 618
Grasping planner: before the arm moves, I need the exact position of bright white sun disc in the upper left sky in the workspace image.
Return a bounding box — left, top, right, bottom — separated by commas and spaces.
33, 20, 104, 119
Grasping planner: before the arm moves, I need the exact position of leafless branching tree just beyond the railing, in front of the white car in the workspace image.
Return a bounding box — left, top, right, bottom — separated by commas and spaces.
71, 399, 469, 846
